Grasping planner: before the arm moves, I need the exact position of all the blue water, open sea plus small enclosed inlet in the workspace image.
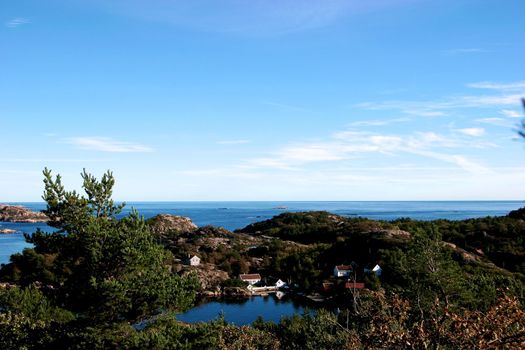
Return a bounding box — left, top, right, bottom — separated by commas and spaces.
0, 201, 525, 326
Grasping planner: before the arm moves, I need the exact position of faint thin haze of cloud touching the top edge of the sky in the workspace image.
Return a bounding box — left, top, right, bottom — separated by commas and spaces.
84, 0, 413, 35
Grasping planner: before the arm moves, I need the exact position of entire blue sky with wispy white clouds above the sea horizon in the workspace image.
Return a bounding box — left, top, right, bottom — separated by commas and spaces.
0, 0, 525, 202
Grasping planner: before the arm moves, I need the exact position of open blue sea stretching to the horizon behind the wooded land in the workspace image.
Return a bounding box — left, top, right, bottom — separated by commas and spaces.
0, 201, 525, 264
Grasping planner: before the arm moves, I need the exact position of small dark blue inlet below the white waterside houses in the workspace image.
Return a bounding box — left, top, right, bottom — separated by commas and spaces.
177, 295, 305, 326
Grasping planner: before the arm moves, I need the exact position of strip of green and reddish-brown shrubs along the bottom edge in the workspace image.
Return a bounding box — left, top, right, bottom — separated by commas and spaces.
0, 291, 525, 350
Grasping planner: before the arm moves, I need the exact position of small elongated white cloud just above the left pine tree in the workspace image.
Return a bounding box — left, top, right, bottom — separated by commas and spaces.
65, 136, 153, 153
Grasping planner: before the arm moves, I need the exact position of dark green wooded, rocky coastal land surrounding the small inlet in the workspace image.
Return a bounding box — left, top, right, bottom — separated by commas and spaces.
0, 170, 525, 349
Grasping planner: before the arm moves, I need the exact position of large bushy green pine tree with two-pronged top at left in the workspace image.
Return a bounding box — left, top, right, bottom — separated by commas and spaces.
0, 169, 196, 323
